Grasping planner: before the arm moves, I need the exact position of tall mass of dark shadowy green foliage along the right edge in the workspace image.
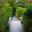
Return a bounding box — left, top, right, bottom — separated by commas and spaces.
24, 4, 32, 31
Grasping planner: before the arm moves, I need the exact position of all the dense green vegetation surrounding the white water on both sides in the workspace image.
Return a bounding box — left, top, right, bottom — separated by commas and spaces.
0, 0, 32, 32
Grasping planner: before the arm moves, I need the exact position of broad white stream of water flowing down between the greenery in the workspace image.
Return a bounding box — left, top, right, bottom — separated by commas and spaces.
8, 16, 24, 32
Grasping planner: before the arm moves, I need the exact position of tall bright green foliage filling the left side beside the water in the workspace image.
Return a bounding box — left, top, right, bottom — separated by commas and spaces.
0, 3, 13, 32
